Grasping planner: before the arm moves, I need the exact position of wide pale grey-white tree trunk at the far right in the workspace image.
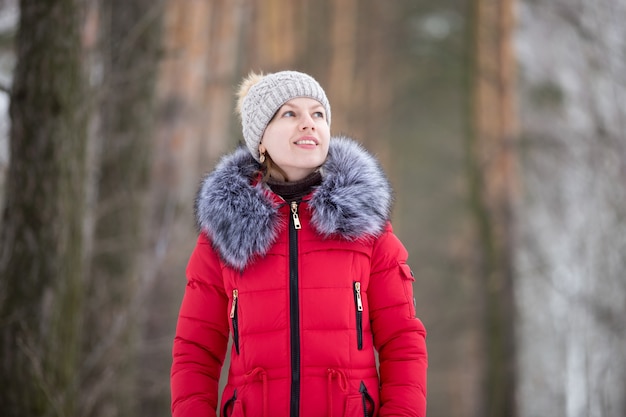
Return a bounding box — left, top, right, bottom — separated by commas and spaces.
516, 0, 626, 417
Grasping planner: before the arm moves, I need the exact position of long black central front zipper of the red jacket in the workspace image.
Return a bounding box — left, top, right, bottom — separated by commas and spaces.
289, 201, 302, 417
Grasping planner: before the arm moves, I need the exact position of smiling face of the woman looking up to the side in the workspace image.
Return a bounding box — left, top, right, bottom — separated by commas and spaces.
261, 97, 330, 181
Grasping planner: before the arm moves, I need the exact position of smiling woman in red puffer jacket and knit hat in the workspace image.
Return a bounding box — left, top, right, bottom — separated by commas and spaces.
171, 71, 427, 417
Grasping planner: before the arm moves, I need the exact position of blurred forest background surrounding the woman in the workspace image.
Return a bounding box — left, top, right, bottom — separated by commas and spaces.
0, 0, 626, 417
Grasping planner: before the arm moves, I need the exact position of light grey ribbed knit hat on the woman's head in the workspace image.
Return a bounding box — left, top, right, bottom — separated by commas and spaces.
239, 71, 330, 161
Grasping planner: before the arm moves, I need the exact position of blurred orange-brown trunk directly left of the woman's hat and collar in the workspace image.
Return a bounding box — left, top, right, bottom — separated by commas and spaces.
140, 0, 245, 415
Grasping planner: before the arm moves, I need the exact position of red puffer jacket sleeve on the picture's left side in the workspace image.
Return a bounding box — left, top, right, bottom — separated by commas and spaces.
170, 234, 229, 417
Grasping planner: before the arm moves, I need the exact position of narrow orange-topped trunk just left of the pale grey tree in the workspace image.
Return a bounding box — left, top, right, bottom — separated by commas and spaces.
468, 0, 516, 417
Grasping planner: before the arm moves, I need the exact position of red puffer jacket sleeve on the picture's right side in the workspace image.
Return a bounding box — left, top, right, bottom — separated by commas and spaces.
367, 224, 428, 417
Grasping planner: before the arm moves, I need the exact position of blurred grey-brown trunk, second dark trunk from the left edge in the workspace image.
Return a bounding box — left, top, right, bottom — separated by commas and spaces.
81, 0, 163, 417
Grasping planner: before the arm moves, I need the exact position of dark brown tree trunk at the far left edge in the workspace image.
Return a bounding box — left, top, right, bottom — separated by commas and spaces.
0, 0, 86, 417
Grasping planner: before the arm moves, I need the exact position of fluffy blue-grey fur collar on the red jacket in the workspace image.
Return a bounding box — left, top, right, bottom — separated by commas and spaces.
195, 137, 392, 270
